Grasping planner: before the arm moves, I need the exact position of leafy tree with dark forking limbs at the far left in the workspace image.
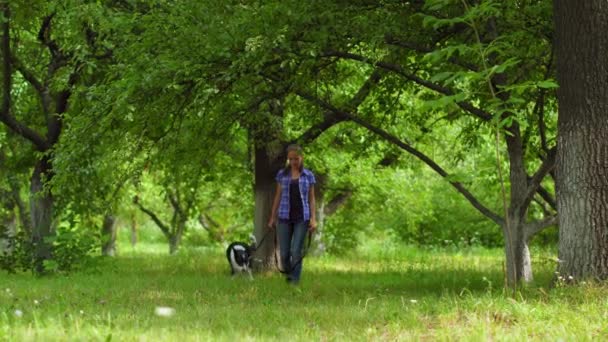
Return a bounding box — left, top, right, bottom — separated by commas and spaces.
0, 1, 114, 273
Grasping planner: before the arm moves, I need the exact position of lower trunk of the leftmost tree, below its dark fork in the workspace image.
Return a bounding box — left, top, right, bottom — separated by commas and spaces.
30, 158, 55, 275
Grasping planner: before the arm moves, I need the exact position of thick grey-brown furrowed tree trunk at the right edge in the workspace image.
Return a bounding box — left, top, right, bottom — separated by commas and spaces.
554, 0, 608, 280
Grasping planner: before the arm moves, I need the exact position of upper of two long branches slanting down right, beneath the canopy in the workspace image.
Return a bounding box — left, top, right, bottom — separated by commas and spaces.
321, 51, 492, 121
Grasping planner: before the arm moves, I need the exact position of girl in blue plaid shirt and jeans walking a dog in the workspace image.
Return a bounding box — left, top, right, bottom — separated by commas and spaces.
268, 145, 317, 284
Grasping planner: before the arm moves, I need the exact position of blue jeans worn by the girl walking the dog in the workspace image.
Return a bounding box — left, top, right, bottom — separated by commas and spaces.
277, 221, 308, 282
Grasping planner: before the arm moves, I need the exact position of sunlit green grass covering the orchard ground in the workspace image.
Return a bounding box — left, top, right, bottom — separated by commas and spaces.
0, 244, 608, 342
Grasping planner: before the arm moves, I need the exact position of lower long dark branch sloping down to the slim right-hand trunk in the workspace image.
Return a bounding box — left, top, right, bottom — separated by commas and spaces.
296, 90, 504, 226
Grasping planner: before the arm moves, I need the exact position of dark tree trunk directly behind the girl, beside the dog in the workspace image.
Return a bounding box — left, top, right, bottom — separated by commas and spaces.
254, 145, 284, 269
